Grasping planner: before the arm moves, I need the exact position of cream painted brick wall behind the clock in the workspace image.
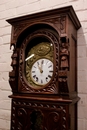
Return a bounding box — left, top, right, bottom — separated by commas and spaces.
0, 0, 87, 130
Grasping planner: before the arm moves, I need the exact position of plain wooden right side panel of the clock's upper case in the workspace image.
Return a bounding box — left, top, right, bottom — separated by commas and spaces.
67, 17, 78, 98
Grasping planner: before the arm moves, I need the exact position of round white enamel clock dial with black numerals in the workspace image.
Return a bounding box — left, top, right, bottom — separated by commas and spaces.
31, 58, 53, 85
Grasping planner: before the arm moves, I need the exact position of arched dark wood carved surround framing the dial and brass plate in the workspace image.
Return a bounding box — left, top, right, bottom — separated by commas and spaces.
19, 29, 59, 93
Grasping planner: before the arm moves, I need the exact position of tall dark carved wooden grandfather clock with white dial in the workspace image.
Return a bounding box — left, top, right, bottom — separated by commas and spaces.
7, 6, 81, 130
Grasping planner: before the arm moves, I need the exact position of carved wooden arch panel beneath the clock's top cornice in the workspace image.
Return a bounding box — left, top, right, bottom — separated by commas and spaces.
11, 16, 66, 43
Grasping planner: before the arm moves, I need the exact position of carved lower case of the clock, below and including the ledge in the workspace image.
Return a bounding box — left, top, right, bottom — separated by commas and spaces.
10, 95, 79, 130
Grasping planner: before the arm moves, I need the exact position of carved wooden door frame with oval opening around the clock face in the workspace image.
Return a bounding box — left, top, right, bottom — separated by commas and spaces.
18, 25, 59, 94
